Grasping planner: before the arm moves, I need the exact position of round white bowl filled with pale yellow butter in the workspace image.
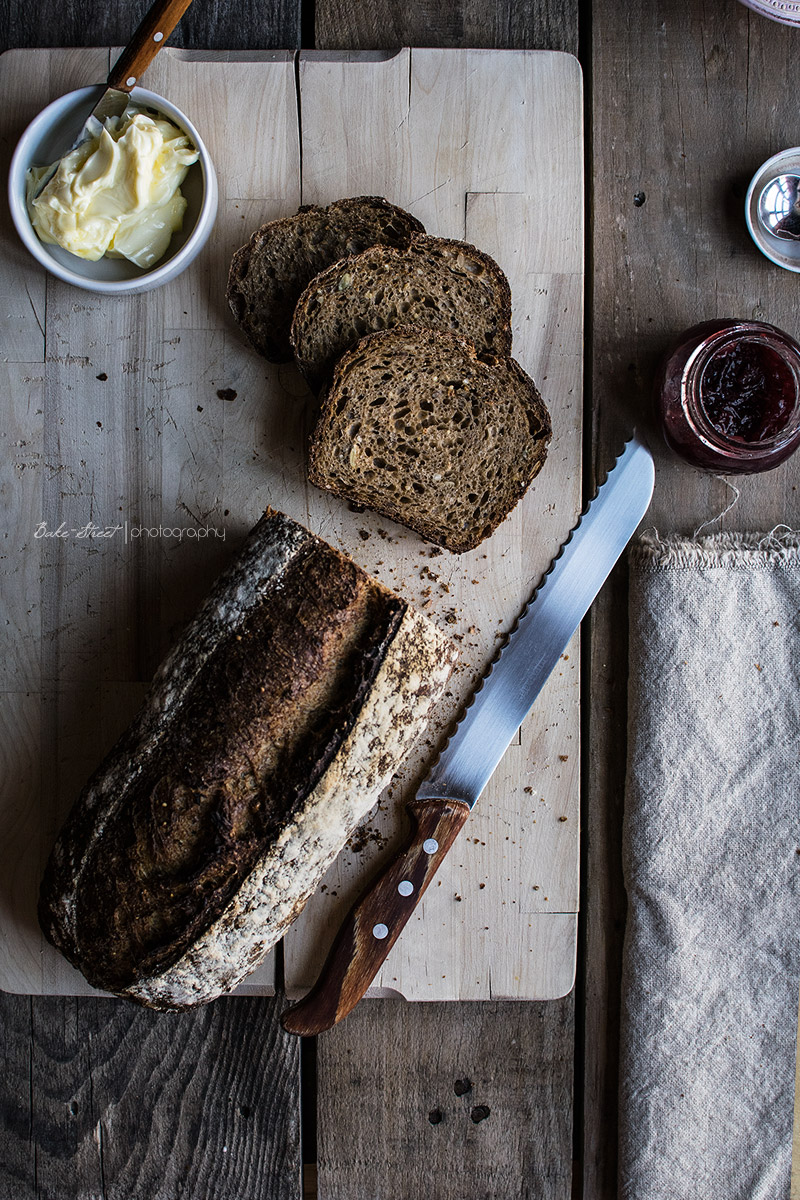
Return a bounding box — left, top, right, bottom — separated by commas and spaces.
8, 88, 217, 295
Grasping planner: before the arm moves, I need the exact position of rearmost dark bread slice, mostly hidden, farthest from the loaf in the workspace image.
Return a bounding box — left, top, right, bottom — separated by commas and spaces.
225, 196, 425, 362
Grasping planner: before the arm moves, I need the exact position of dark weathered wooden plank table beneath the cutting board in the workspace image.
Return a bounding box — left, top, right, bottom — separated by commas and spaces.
0, 0, 800, 1200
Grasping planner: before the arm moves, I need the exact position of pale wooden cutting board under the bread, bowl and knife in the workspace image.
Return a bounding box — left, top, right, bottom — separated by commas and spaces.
0, 49, 583, 1000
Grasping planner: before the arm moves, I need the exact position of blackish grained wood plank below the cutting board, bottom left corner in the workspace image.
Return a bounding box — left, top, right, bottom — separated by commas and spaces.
0, 996, 301, 1200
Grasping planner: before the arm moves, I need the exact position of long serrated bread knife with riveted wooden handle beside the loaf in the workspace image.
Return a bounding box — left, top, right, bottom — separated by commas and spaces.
281, 437, 655, 1037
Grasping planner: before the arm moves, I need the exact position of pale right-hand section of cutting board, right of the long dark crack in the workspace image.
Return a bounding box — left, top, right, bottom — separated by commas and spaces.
281, 49, 583, 1000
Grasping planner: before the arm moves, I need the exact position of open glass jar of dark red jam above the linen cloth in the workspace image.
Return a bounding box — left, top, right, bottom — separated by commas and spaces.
656, 319, 800, 474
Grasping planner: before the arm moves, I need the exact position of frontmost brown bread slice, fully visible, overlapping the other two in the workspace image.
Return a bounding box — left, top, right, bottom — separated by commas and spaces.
308, 326, 551, 553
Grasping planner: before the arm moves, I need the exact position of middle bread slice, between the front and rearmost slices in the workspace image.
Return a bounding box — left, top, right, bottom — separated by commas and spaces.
291, 235, 511, 389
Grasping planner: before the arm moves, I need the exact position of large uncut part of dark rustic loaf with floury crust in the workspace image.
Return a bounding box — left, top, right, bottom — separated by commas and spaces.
40, 510, 455, 1009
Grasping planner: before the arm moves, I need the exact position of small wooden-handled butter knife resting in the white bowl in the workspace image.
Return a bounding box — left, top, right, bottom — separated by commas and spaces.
34, 0, 192, 199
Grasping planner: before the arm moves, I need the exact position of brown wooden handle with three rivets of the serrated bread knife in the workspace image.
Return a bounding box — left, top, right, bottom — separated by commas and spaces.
281, 800, 469, 1037
